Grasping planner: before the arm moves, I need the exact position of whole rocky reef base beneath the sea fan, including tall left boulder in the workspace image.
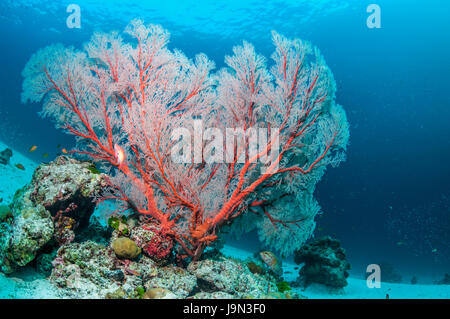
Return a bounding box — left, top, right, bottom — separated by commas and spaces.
0, 151, 310, 299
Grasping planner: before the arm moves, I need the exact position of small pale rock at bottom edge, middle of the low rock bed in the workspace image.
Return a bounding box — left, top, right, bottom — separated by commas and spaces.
144, 265, 197, 298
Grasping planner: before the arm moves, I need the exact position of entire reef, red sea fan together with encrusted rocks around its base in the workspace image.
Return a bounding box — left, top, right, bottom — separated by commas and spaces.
8, 20, 349, 299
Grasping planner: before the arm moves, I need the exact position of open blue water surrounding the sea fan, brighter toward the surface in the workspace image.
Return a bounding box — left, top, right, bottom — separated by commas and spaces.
0, 0, 450, 288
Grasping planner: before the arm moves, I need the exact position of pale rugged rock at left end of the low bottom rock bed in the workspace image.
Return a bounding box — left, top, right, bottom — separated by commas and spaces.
49, 241, 158, 299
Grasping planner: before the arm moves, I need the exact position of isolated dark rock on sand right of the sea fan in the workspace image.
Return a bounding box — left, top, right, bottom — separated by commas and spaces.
294, 237, 350, 288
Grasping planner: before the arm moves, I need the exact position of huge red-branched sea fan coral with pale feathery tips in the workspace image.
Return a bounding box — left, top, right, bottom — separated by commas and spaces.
22, 20, 349, 260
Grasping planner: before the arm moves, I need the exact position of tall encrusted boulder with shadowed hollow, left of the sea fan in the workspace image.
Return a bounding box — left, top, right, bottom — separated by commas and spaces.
0, 156, 106, 273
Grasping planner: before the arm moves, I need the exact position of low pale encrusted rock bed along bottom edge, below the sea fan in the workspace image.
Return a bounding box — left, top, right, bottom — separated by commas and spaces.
50, 241, 278, 299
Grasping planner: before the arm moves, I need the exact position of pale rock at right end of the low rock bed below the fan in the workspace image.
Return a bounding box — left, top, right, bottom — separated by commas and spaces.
187, 257, 277, 298
